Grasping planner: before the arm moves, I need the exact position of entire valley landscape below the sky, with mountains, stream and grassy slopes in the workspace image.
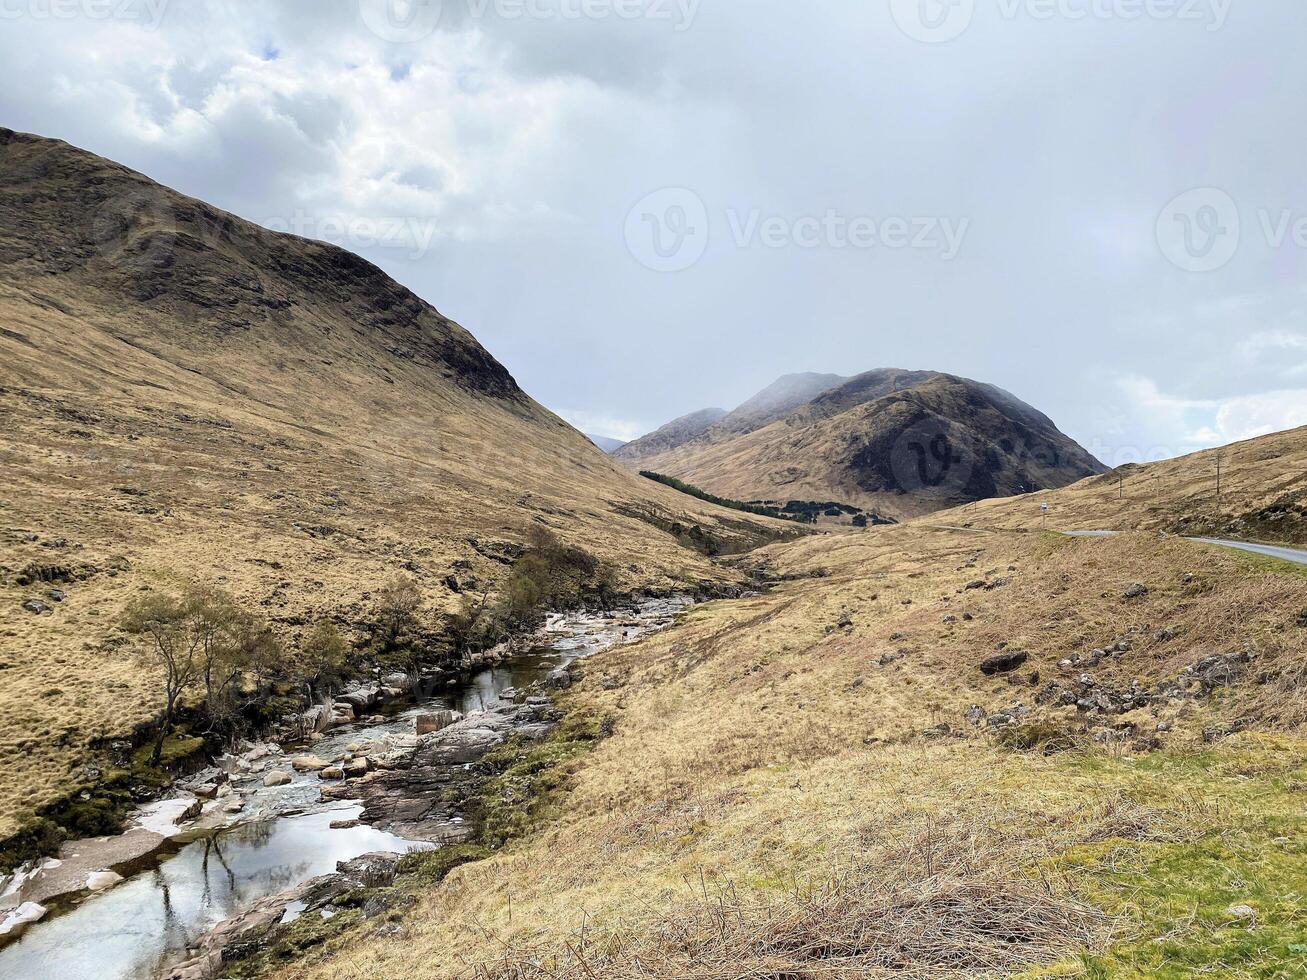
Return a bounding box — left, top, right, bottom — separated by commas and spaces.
0, 129, 1307, 980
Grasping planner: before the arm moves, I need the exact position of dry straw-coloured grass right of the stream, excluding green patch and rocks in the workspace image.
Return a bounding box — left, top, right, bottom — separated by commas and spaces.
288, 527, 1307, 980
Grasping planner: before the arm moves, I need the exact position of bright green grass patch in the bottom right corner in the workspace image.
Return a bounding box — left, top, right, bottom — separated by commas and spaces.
1042, 736, 1307, 980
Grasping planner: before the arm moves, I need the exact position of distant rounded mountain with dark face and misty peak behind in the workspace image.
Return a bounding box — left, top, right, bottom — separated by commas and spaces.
618, 368, 1103, 519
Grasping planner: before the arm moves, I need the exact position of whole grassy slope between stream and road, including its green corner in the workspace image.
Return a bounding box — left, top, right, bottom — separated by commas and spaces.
275, 525, 1307, 980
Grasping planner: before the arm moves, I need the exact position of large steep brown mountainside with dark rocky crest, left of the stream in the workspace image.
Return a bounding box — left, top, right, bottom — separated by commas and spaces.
0, 129, 793, 839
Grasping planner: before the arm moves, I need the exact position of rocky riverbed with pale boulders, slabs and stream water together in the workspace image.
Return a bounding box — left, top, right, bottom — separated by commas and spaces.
0, 598, 690, 980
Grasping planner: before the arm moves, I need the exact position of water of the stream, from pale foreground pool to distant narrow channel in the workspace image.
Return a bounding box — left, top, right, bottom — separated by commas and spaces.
0, 598, 690, 980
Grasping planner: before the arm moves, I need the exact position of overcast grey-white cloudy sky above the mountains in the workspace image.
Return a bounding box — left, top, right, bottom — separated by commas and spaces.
0, 0, 1307, 464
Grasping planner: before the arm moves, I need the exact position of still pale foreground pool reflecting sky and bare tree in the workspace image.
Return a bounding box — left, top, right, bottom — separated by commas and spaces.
0, 806, 414, 980
